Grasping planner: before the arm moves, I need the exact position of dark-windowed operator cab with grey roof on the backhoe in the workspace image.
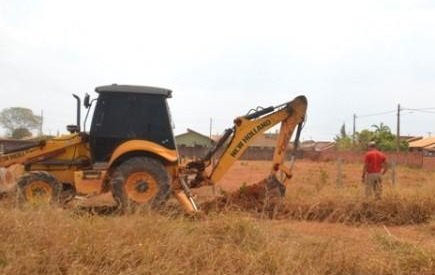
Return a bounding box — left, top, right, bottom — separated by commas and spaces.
85, 84, 176, 162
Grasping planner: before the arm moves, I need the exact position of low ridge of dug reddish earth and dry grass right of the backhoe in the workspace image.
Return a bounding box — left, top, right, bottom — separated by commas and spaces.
201, 181, 435, 225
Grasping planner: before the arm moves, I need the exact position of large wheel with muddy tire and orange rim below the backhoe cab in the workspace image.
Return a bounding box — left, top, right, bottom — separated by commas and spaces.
110, 157, 171, 213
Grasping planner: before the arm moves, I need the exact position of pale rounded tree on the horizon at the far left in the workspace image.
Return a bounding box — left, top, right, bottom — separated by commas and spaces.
0, 107, 42, 136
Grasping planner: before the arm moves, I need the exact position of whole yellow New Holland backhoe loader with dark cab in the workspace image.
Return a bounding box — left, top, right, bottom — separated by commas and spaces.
0, 84, 307, 213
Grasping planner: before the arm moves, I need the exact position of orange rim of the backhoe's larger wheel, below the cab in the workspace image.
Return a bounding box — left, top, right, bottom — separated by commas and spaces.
125, 172, 159, 203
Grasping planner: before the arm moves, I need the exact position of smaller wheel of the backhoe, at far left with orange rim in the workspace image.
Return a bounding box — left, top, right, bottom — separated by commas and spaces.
17, 171, 62, 205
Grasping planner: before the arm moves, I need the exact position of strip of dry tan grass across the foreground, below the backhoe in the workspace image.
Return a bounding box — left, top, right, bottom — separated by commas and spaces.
0, 208, 435, 274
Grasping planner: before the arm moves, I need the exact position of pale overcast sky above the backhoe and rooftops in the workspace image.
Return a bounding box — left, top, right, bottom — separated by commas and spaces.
0, 0, 435, 140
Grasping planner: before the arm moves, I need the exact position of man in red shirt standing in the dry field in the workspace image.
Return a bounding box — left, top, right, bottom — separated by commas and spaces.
362, 141, 388, 199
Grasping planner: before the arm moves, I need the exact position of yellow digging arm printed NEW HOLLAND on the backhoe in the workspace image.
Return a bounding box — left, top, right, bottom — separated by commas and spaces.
175, 96, 308, 215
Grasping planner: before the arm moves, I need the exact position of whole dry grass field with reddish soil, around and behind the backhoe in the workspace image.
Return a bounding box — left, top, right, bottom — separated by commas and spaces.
0, 161, 435, 274
